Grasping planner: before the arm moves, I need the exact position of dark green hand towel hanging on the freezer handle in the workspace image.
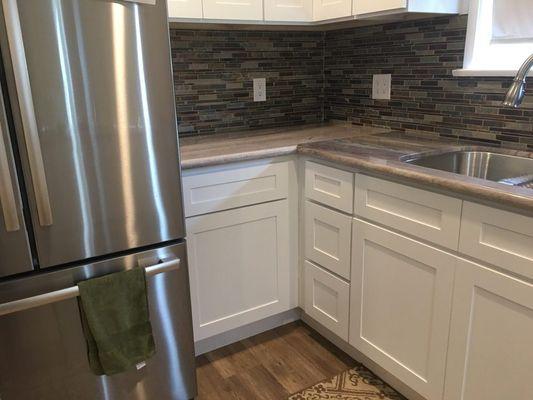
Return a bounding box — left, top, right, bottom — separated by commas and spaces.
78, 268, 155, 375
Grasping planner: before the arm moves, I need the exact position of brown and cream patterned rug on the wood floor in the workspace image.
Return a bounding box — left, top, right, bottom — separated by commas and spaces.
288, 366, 405, 400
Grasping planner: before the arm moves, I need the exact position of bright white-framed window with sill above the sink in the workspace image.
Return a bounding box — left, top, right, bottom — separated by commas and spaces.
454, 0, 533, 76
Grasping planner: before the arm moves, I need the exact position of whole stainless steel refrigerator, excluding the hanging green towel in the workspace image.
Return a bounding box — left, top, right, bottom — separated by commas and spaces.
0, 0, 195, 400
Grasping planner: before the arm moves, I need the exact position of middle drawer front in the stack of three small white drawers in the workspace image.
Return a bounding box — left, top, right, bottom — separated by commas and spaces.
305, 201, 352, 280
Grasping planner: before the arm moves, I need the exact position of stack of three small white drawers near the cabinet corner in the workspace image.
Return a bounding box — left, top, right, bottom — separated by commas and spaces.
304, 161, 354, 340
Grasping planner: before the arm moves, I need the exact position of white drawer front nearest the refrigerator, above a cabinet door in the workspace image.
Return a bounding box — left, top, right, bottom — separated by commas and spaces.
183, 162, 289, 217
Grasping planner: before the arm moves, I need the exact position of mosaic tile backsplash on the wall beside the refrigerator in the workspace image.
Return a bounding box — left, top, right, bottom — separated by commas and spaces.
170, 26, 324, 136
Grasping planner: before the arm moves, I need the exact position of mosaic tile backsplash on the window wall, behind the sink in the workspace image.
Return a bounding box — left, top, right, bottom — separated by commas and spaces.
325, 16, 533, 149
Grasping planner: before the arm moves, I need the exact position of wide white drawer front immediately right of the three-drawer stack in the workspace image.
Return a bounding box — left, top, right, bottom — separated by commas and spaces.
355, 174, 462, 250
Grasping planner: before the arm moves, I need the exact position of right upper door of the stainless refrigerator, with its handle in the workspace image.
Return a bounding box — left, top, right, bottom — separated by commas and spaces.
0, 0, 185, 268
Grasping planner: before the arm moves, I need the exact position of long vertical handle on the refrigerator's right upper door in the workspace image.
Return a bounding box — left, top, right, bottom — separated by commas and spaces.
2, 0, 53, 226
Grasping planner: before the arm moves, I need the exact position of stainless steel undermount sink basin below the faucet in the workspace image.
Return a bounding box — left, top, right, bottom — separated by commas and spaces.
403, 151, 533, 189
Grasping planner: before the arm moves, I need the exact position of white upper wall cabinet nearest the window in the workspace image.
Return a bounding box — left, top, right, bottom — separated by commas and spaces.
353, 0, 463, 18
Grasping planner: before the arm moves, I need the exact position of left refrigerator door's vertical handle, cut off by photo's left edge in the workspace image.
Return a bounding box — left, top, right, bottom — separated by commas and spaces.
0, 117, 20, 232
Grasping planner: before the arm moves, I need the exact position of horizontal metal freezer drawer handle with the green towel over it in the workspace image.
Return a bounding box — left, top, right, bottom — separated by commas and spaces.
0, 258, 181, 317
